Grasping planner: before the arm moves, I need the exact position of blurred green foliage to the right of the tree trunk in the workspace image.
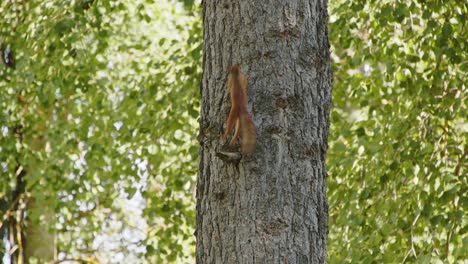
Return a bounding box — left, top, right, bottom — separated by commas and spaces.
327, 0, 468, 263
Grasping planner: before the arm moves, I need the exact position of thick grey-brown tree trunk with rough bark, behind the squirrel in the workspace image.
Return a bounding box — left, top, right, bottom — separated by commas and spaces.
196, 0, 331, 263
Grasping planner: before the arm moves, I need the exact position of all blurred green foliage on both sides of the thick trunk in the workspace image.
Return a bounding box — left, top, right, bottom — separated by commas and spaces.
0, 0, 468, 263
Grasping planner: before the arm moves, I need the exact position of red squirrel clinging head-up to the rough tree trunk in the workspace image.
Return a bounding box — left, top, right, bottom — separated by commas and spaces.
221, 64, 257, 155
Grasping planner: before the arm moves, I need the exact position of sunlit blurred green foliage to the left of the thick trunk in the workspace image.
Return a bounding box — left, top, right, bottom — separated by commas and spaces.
0, 0, 201, 263
